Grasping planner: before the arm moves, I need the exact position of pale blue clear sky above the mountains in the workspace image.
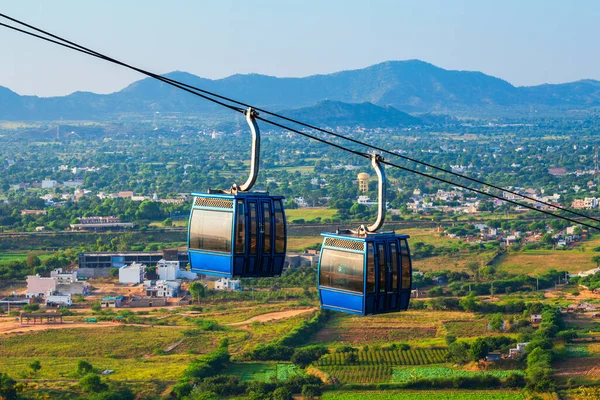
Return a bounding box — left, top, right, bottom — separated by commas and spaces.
0, 0, 600, 96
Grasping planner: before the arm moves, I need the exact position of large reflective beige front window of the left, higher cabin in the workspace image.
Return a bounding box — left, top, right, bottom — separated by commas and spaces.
190, 209, 233, 253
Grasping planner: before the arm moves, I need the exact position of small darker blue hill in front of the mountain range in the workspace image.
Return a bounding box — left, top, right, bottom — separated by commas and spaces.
281, 100, 423, 128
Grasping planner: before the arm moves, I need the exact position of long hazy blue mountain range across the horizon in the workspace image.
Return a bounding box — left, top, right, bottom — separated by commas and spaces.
0, 60, 600, 126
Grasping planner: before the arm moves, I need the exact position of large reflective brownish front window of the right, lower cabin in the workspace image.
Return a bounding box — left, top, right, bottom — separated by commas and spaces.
320, 249, 364, 293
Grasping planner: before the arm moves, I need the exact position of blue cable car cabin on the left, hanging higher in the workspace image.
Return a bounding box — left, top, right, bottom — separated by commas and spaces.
188, 193, 286, 278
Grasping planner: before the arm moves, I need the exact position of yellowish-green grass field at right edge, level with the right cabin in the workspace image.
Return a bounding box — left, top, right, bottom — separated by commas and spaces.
494, 250, 596, 275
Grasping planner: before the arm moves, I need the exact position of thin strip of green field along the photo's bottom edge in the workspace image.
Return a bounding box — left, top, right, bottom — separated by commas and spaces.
321, 390, 525, 400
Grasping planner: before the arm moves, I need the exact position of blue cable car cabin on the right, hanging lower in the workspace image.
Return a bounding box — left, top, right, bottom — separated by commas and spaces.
319, 232, 412, 315
